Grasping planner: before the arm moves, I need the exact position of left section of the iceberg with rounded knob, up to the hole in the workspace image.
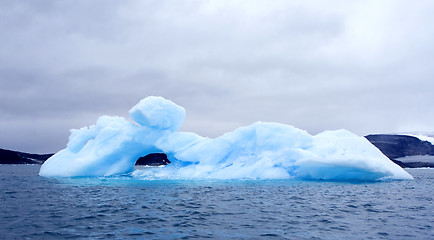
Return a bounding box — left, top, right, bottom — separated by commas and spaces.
39, 97, 185, 177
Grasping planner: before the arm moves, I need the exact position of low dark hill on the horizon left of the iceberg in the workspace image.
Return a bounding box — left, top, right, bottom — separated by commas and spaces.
0, 148, 53, 164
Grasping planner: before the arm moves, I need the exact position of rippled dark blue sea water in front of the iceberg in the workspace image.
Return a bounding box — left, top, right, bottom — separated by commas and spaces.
0, 165, 434, 239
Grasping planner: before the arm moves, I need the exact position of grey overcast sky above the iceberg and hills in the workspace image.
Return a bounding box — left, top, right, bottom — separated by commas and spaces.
0, 0, 434, 153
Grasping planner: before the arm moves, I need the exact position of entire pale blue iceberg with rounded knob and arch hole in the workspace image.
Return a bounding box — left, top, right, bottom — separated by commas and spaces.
39, 97, 413, 181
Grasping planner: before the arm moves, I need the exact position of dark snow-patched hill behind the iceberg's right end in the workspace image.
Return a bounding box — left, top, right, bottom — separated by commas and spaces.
365, 134, 434, 167
